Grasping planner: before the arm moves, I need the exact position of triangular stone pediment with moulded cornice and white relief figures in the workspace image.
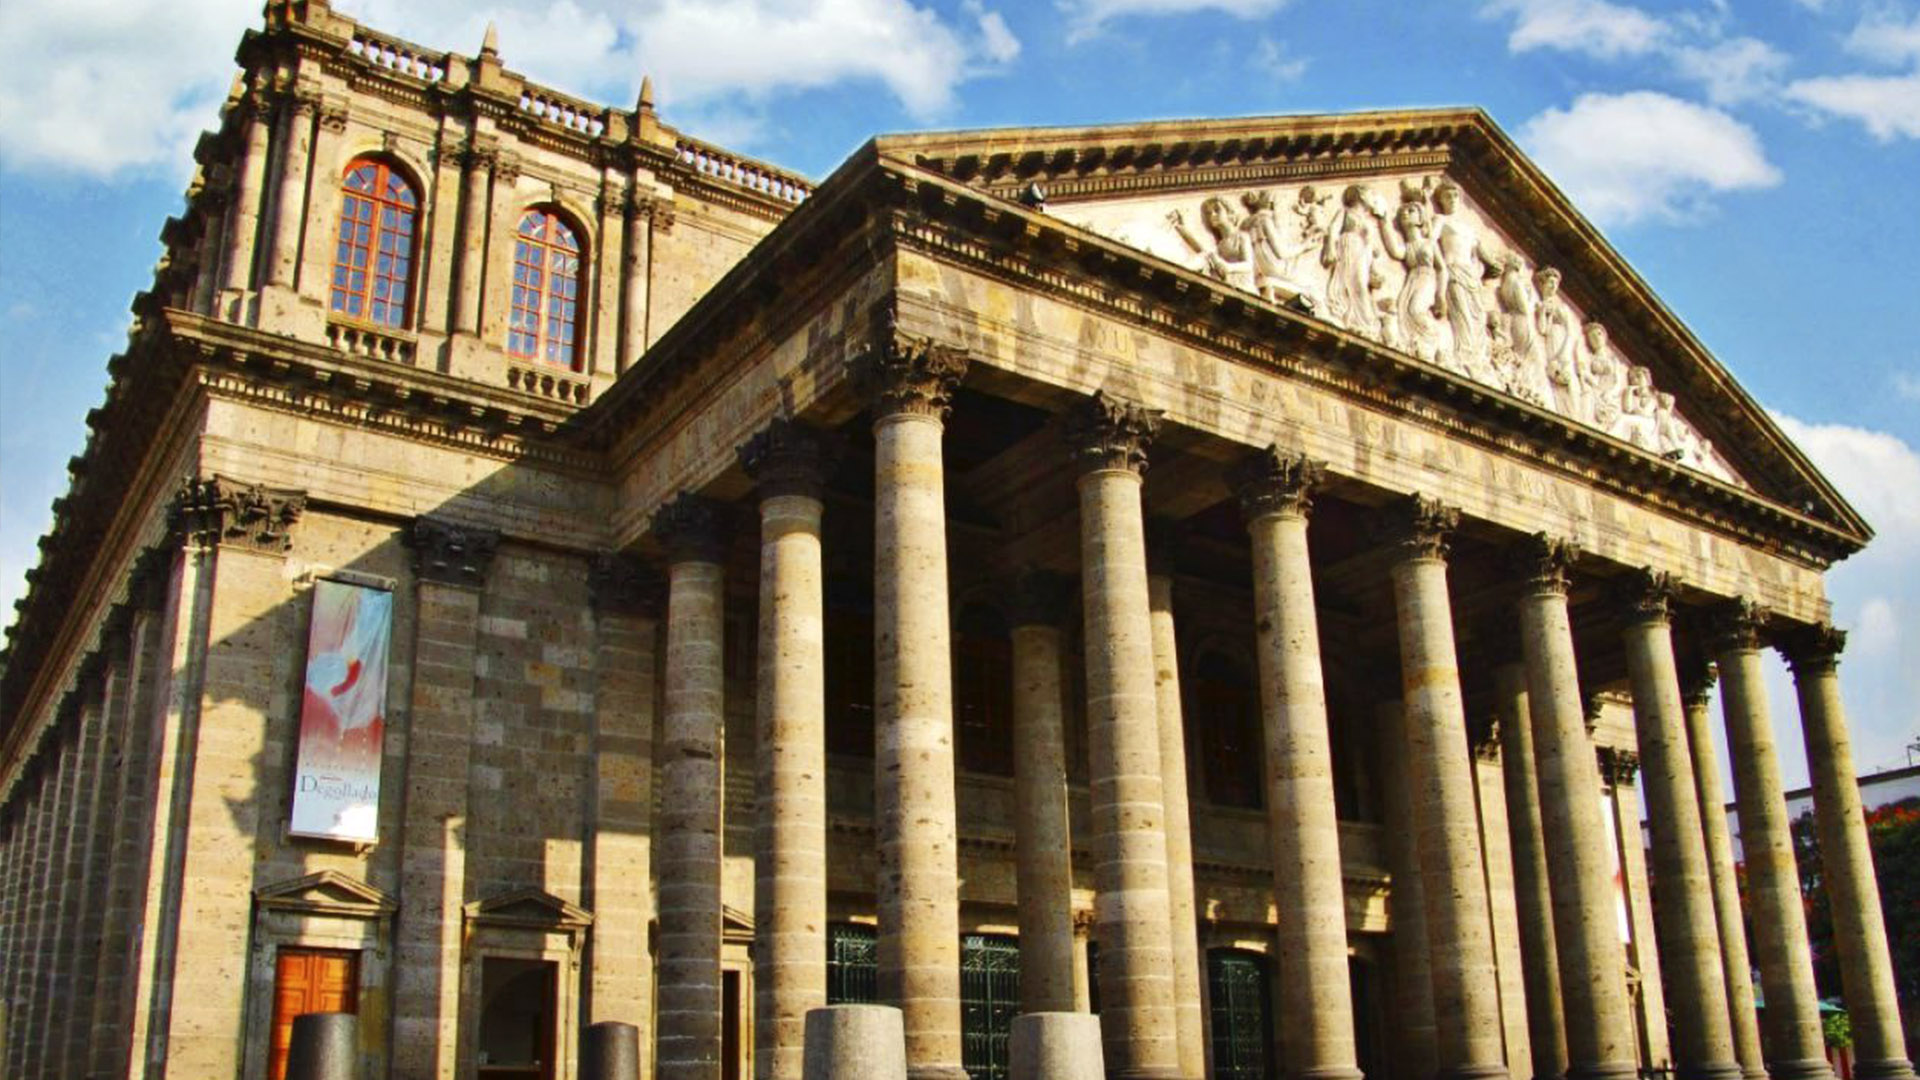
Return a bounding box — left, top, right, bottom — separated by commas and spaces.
877, 110, 1870, 542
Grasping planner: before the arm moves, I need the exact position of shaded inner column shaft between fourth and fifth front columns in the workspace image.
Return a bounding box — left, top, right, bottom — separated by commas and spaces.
1494, 663, 1567, 1080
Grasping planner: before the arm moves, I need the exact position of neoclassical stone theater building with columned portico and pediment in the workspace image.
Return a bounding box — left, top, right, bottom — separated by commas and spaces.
0, 0, 1912, 1080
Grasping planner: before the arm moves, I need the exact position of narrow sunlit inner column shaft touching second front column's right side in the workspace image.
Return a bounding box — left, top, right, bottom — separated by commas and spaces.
1146, 568, 1206, 1076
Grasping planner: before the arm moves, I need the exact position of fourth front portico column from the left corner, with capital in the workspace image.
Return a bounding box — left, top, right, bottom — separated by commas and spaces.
1392, 496, 1505, 1080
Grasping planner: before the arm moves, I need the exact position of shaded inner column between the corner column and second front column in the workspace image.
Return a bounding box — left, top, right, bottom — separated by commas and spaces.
1014, 571, 1077, 1013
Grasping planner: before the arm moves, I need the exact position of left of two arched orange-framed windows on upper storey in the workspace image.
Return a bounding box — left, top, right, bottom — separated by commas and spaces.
332, 158, 420, 327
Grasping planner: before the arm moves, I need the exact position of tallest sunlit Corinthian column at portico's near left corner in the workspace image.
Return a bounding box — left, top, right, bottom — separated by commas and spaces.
866, 334, 966, 1080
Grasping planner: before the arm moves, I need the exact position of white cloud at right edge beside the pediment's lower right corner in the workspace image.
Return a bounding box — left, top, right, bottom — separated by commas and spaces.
1774, 413, 1920, 771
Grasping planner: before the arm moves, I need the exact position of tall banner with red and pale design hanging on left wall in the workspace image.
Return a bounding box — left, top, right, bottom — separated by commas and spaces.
288, 578, 394, 842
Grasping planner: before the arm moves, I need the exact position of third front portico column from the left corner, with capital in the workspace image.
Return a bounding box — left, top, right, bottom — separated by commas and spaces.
1231, 446, 1359, 1080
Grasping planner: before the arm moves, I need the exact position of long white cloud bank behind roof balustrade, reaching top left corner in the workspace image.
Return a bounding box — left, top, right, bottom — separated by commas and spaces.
0, 0, 1020, 177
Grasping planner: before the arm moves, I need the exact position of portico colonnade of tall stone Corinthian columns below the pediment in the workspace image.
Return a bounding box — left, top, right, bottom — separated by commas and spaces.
637, 367, 1912, 1080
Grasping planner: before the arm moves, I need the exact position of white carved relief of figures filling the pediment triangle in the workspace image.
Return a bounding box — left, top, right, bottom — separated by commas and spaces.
1048, 175, 1745, 486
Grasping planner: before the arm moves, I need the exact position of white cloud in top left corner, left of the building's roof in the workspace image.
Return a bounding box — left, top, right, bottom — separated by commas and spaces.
0, 0, 259, 177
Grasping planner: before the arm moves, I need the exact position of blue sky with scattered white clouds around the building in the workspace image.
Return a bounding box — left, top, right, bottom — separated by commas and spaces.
0, 0, 1920, 784
